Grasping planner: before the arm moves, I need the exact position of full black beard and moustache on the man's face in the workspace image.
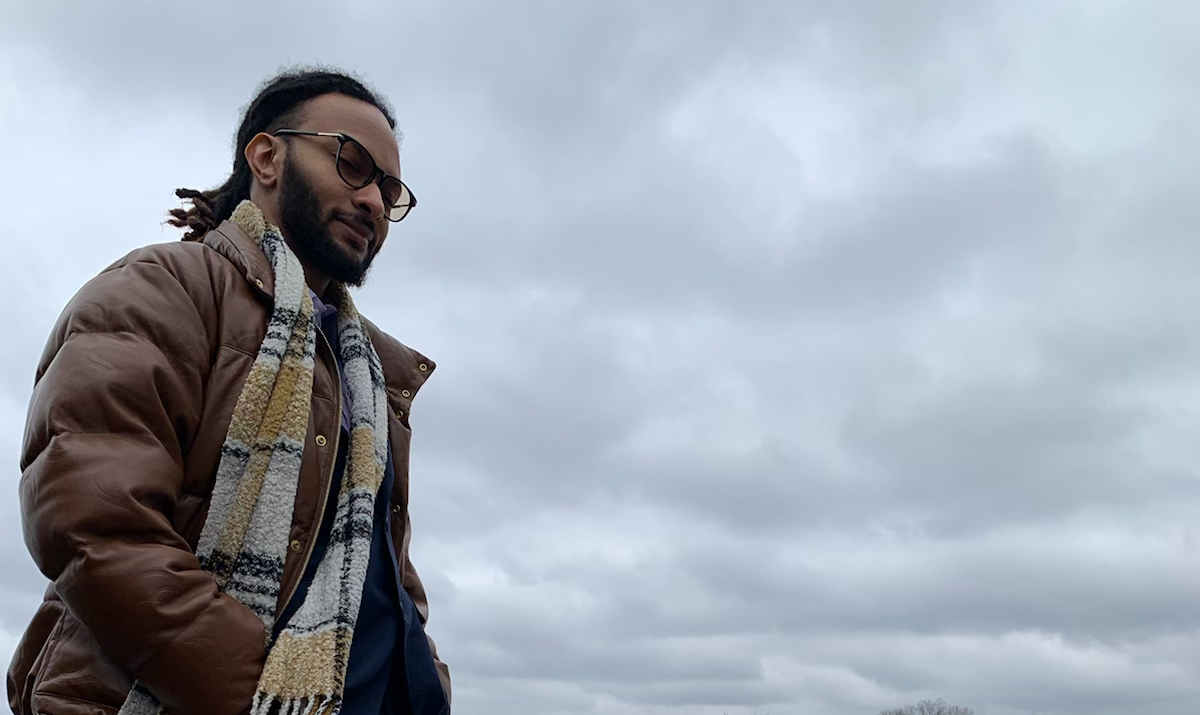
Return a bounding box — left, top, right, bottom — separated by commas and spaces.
280, 157, 379, 287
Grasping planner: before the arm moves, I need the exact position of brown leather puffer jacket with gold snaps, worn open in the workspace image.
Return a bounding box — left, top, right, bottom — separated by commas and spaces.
8, 221, 450, 715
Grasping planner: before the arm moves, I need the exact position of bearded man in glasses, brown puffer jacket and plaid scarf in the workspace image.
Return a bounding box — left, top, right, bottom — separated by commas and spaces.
8, 70, 450, 715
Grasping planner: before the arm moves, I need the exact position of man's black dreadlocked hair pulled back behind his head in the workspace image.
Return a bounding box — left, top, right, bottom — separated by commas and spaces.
167, 67, 396, 241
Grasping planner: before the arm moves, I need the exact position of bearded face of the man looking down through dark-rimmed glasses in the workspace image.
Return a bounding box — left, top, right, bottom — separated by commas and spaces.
278, 95, 400, 286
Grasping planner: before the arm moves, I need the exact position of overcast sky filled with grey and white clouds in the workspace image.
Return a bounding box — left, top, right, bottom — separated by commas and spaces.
0, 0, 1200, 715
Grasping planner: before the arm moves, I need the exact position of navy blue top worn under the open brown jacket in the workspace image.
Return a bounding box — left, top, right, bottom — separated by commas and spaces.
276, 295, 450, 715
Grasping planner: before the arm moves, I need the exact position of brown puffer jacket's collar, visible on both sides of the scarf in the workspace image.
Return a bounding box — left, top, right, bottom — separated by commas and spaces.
202, 221, 437, 398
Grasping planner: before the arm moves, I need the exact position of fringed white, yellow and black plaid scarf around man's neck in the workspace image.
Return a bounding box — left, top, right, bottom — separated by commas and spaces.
120, 200, 388, 715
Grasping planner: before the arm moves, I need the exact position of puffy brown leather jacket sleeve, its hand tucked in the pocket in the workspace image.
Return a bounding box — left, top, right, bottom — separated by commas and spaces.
20, 256, 265, 715
